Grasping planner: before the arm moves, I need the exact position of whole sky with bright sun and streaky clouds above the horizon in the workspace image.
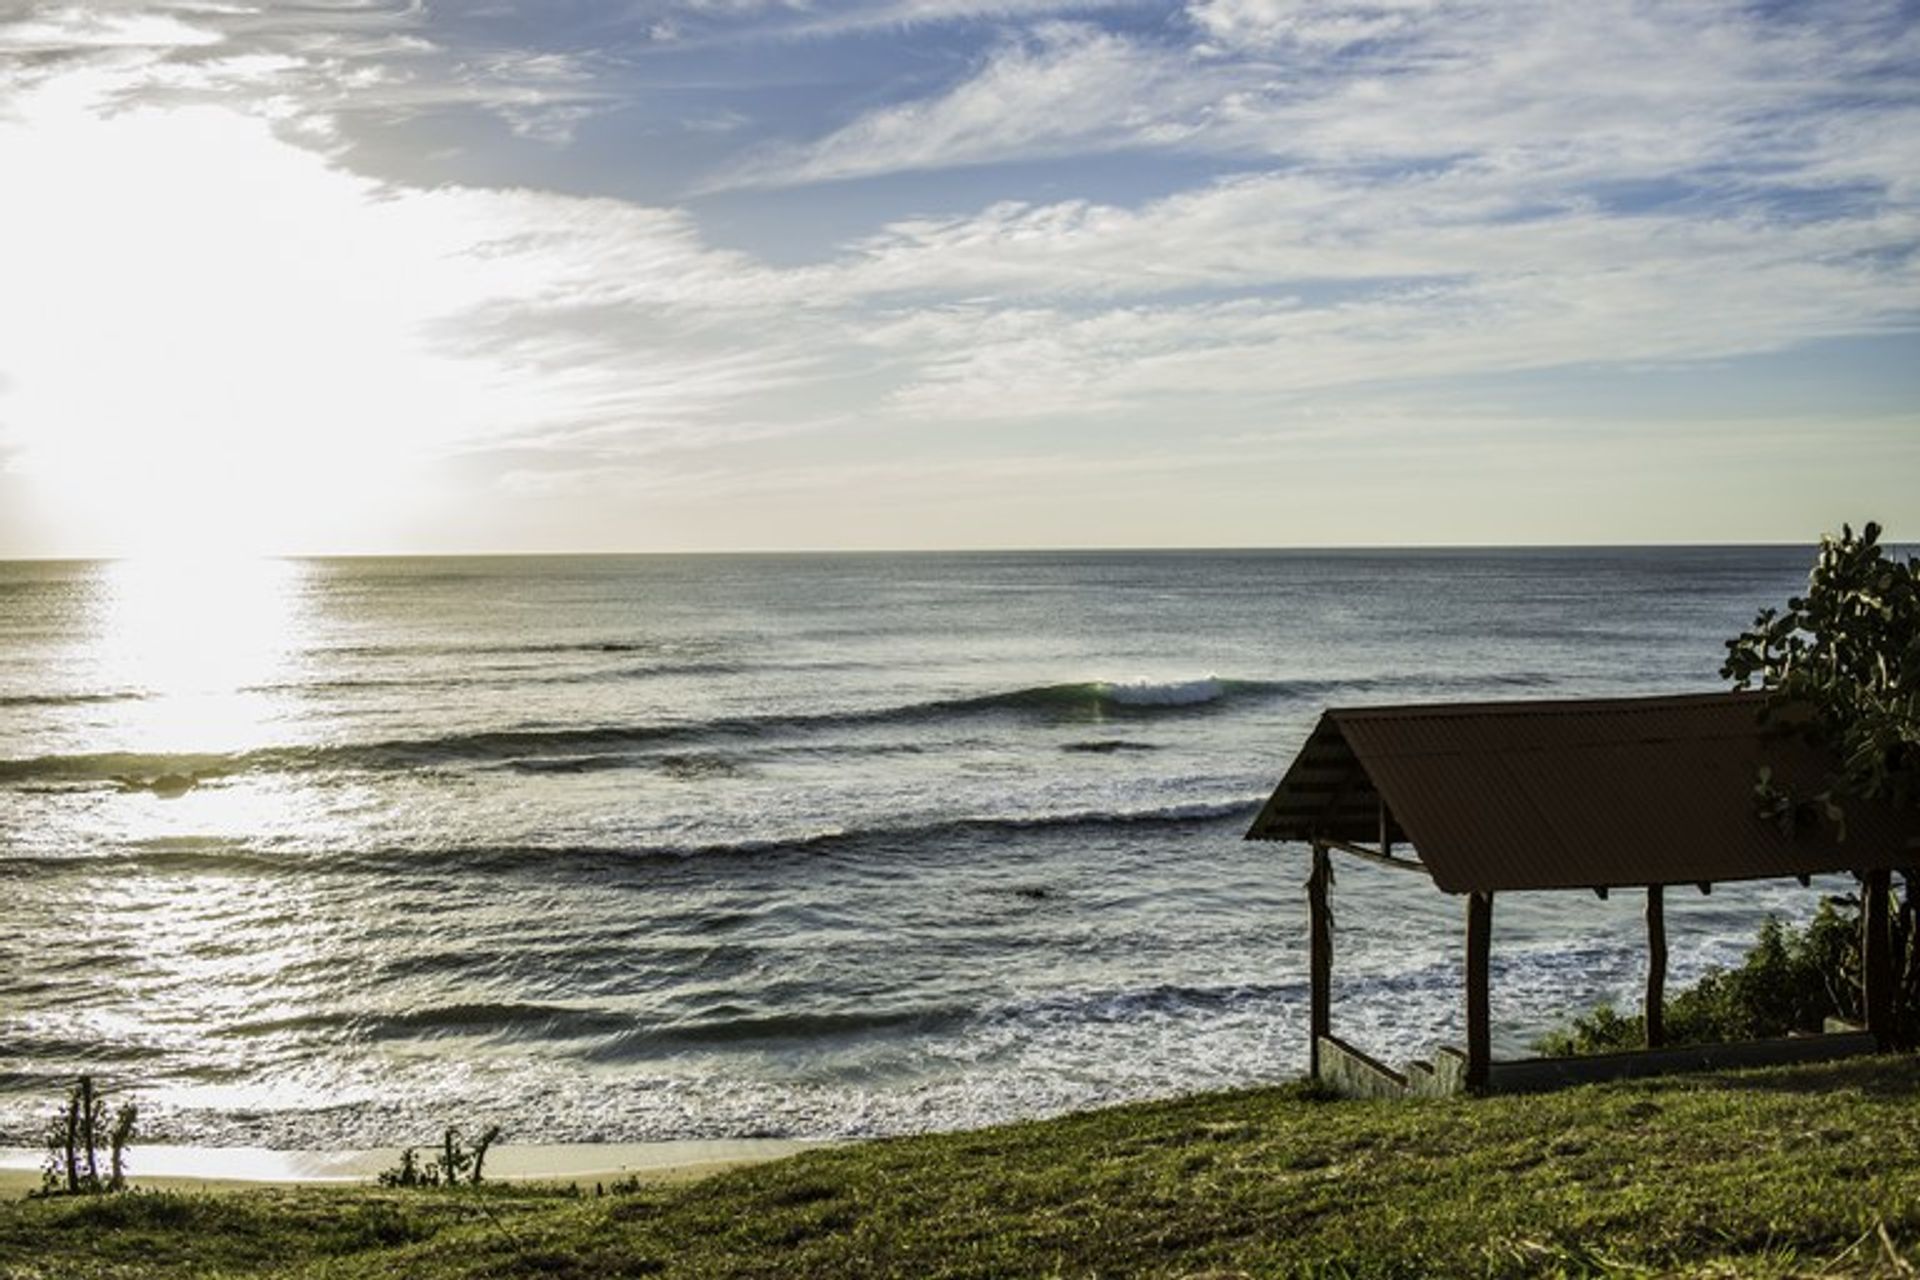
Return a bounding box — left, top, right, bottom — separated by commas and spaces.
0, 0, 1920, 557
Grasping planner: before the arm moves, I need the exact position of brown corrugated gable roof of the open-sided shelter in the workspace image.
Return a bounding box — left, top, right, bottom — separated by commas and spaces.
1246, 693, 1920, 892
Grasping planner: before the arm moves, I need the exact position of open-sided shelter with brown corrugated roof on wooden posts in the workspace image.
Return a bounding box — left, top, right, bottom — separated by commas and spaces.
1246, 693, 1920, 1092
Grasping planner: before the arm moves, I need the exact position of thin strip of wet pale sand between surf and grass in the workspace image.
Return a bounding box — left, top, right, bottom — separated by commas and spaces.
0, 1138, 817, 1197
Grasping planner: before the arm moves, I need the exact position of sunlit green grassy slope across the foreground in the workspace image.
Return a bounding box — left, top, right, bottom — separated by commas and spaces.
0, 1057, 1920, 1280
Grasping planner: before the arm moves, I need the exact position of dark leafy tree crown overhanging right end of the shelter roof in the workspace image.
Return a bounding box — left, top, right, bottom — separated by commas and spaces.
1720, 524, 1920, 821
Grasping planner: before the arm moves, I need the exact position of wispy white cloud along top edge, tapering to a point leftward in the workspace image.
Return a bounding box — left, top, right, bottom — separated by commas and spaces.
716, 0, 1920, 196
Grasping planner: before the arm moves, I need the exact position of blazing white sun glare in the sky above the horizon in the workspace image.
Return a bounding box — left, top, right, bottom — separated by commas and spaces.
0, 75, 541, 557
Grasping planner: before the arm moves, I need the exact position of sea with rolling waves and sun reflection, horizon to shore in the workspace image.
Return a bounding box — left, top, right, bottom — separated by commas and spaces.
0, 549, 1816, 1146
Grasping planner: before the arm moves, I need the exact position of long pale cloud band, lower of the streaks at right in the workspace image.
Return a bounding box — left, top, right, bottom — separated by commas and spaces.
856, 204, 1920, 418
